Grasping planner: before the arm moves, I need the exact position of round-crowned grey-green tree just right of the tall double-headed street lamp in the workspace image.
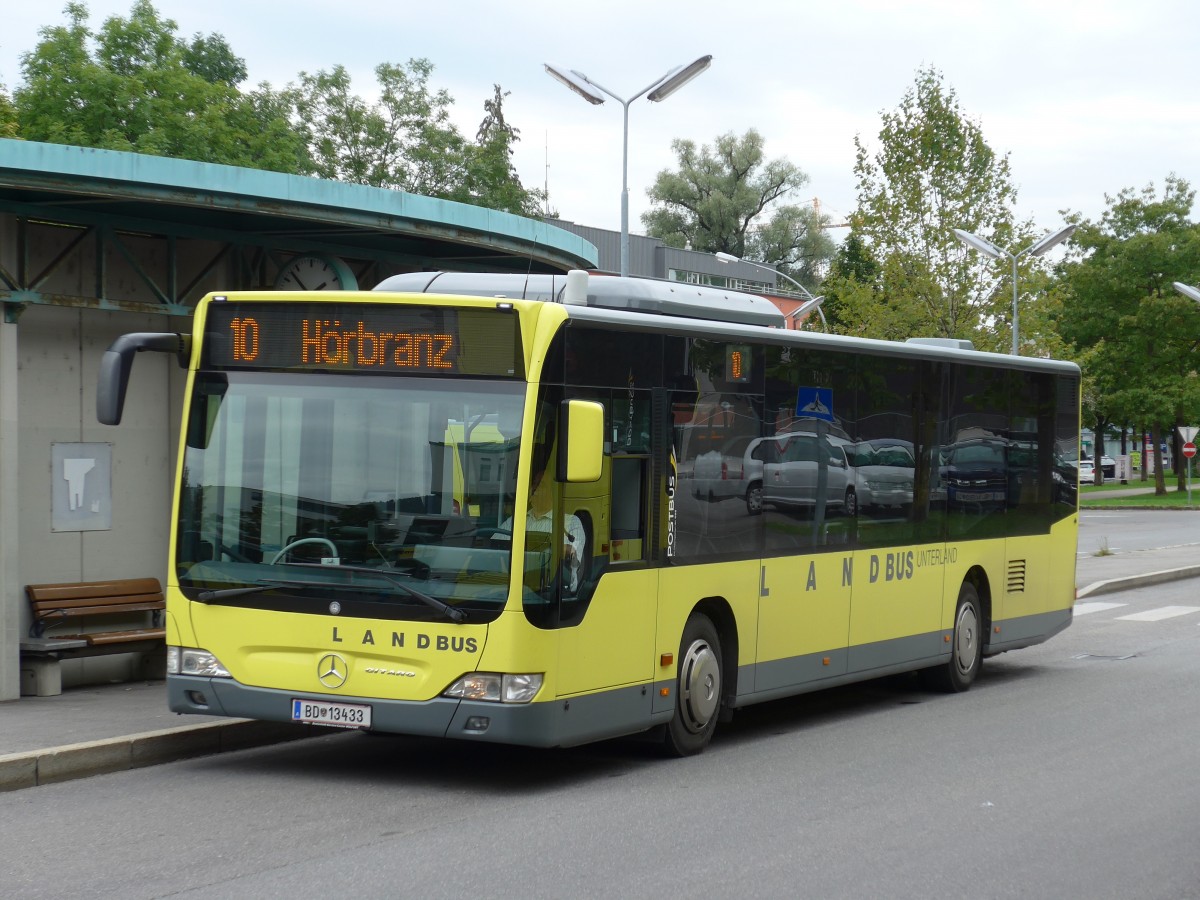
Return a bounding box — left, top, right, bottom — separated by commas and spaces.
642, 128, 834, 289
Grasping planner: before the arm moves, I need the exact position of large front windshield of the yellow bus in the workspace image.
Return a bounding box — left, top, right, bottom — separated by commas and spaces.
175, 372, 524, 622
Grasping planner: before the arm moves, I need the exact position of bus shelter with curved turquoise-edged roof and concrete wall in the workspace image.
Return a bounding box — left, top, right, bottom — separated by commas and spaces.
0, 140, 598, 701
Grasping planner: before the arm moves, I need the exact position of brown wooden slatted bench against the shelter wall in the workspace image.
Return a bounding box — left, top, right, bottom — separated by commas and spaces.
20, 578, 167, 696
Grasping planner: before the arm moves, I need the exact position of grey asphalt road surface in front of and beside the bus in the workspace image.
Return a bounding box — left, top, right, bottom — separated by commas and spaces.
0, 581, 1200, 900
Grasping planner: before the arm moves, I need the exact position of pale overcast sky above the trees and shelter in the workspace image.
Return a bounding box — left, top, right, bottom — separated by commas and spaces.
0, 0, 1200, 247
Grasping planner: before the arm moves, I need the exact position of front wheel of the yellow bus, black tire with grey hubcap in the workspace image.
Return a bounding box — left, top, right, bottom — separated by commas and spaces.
662, 613, 724, 756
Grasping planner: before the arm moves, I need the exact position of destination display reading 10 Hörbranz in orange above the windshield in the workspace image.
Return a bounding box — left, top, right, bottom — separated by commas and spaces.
204, 301, 524, 378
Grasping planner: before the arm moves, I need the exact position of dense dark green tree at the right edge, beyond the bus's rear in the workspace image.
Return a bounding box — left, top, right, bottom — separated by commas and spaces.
1057, 175, 1200, 493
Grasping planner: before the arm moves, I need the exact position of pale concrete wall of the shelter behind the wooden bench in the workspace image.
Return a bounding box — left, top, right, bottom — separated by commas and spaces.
0, 306, 184, 686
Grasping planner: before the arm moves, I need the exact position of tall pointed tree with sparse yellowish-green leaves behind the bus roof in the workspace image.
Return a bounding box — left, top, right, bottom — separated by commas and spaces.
824, 68, 1039, 350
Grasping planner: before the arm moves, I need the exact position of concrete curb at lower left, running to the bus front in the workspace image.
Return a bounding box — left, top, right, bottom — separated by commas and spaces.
0, 719, 325, 793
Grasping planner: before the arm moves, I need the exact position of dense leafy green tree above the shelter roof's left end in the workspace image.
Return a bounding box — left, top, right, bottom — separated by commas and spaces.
14, 0, 311, 172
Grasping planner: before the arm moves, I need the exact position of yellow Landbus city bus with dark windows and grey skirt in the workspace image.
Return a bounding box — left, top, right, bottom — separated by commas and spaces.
97, 272, 1079, 756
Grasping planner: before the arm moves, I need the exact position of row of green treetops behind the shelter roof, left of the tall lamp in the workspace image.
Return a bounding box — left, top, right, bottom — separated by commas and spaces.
10, 0, 545, 215
